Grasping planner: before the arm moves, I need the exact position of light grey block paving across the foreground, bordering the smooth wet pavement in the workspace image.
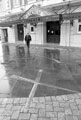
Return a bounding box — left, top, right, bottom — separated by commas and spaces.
0, 94, 81, 120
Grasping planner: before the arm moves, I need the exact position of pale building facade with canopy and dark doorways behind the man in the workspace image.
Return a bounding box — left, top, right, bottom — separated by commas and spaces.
0, 0, 81, 47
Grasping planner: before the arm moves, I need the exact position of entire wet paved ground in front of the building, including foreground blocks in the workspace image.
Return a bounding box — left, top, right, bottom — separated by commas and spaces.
0, 44, 81, 120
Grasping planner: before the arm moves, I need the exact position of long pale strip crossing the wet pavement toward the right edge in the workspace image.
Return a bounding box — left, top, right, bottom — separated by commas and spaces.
11, 75, 79, 93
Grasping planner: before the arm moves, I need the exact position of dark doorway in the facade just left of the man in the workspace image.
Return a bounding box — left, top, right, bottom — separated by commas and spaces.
17, 24, 24, 41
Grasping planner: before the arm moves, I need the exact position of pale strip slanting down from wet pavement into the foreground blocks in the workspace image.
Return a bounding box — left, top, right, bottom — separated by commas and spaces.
21, 70, 43, 112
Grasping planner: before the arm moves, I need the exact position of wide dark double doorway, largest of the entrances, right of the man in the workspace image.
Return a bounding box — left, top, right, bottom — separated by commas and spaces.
46, 21, 60, 44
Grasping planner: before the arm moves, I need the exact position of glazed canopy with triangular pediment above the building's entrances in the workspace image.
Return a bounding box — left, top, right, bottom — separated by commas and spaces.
0, 2, 81, 27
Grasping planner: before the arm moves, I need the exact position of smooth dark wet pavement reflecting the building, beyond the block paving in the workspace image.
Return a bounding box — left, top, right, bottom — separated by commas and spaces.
0, 45, 81, 97
